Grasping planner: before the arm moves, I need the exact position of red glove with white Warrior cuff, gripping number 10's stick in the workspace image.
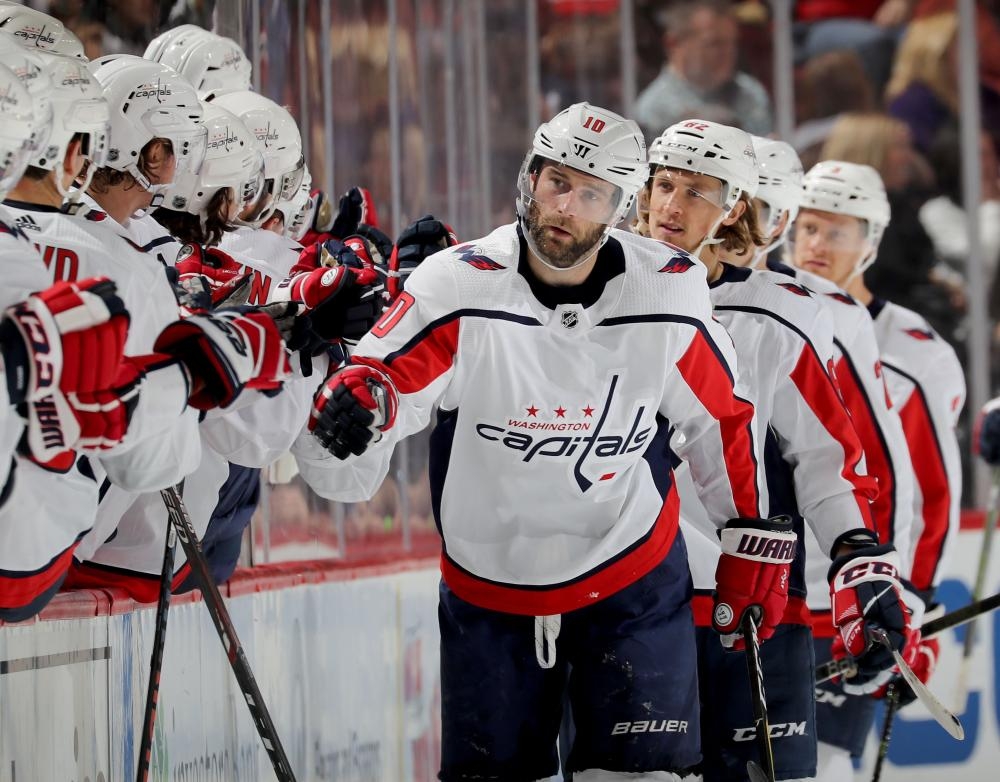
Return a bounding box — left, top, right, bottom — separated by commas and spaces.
712, 516, 796, 650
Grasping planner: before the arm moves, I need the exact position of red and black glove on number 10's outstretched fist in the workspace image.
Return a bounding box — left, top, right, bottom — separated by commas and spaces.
309, 364, 399, 459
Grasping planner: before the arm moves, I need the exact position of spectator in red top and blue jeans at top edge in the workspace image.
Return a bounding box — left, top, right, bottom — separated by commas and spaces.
794, 0, 916, 94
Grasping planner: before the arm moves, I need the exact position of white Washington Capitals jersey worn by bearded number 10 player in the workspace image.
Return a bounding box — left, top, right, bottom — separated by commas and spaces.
298, 225, 766, 616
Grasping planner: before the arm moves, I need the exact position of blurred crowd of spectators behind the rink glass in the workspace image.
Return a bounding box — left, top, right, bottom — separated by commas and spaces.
13, 0, 1000, 559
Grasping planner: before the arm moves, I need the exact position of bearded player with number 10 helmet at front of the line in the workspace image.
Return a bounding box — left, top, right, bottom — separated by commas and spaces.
299, 103, 794, 782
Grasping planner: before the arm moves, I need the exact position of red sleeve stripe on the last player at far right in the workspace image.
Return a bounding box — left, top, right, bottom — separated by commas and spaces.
899, 378, 951, 590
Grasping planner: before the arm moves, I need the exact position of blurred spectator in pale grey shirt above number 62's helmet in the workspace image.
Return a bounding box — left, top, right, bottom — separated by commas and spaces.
634, 0, 773, 139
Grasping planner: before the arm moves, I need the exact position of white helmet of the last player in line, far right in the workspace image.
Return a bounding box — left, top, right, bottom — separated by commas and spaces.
800, 160, 891, 274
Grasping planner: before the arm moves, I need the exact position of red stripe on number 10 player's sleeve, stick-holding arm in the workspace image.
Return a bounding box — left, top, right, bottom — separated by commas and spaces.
677, 330, 761, 518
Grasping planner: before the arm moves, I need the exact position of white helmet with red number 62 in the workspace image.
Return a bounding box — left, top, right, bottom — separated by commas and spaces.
649, 119, 757, 214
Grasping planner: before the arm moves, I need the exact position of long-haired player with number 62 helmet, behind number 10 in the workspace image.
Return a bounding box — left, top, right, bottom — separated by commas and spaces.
639, 120, 902, 780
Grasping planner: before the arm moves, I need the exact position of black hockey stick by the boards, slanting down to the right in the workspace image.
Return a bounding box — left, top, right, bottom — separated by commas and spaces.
160, 487, 295, 782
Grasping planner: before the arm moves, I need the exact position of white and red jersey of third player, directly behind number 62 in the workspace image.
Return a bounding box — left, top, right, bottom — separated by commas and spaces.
768, 262, 913, 620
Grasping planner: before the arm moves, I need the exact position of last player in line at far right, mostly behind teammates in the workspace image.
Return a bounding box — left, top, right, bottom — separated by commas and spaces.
792, 160, 965, 779
